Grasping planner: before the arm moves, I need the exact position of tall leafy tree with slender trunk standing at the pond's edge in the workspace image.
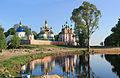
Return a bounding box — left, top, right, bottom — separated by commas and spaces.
71, 1, 101, 51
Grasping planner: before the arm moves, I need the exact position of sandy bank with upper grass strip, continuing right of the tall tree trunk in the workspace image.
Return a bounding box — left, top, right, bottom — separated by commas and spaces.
0, 45, 120, 61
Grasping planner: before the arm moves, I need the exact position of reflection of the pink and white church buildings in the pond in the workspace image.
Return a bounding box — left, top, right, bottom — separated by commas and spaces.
30, 55, 77, 75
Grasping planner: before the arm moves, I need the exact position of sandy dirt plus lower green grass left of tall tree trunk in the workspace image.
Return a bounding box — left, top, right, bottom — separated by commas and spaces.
0, 47, 83, 78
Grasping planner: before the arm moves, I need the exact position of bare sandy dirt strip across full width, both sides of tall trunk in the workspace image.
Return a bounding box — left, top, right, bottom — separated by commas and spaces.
0, 47, 120, 61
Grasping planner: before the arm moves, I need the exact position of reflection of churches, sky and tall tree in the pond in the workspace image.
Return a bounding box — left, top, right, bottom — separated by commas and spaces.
21, 55, 99, 78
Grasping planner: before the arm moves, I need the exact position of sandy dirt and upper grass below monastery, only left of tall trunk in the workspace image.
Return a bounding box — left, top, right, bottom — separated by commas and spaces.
0, 45, 85, 61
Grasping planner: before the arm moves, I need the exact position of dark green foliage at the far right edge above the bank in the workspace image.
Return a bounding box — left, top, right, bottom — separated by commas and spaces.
104, 19, 120, 47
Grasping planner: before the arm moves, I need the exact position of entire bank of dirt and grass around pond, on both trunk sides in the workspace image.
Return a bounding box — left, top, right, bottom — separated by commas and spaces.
0, 45, 120, 78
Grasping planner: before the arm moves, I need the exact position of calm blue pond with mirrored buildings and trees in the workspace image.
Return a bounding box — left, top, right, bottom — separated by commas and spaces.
22, 55, 120, 78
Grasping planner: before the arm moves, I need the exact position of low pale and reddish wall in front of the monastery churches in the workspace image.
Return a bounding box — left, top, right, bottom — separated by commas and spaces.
20, 40, 65, 45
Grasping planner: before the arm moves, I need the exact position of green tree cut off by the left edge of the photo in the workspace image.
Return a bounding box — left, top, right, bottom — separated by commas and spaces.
0, 26, 7, 49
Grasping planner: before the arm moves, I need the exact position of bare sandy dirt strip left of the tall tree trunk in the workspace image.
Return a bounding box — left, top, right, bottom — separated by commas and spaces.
0, 48, 84, 61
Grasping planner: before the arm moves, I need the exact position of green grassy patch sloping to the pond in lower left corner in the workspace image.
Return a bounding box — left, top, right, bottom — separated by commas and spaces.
0, 53, 51, 78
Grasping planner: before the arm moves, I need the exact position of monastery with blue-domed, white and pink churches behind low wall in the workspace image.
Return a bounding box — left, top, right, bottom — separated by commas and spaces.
6, 19, 76, 46
